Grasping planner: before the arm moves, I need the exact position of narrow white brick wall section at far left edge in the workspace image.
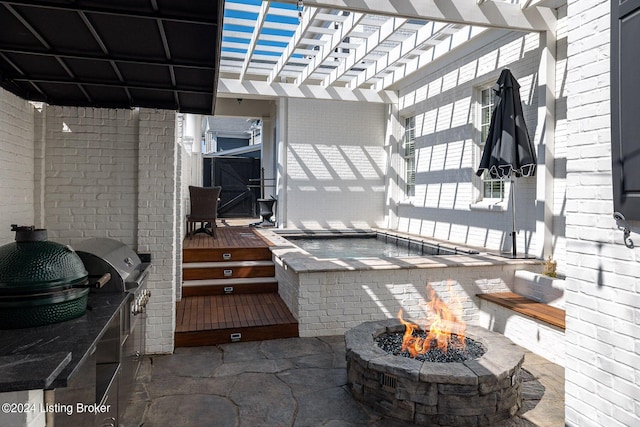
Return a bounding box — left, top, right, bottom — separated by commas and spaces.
0, 88, 37, 244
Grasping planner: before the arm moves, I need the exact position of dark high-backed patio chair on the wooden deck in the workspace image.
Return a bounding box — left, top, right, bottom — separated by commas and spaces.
187, 185, 222, 238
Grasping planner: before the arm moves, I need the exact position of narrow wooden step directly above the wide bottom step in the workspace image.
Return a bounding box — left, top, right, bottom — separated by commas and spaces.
182, 277, 278, 297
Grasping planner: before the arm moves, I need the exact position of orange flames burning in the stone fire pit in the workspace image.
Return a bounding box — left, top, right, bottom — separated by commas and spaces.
398, 284, 466, 357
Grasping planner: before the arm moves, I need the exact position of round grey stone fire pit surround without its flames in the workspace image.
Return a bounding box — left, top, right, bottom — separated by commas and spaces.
345, 319, 524, 427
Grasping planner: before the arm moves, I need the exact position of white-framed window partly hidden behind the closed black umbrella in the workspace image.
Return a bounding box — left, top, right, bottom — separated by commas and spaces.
470, 84, 509, 211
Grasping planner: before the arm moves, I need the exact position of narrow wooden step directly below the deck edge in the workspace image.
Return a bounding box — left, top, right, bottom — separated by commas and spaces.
182, 261, 276, 280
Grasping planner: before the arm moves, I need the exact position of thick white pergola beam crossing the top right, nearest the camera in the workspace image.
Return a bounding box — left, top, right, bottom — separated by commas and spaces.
280, 0, 556, 31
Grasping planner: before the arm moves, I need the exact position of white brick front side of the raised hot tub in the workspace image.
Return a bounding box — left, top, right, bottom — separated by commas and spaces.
276, 256, 515, 336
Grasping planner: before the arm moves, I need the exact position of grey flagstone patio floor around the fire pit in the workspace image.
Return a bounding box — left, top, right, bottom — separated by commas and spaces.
124, 336, 564, 427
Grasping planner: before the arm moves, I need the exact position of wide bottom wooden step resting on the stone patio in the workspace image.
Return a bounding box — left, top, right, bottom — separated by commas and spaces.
175, 293, 298, 347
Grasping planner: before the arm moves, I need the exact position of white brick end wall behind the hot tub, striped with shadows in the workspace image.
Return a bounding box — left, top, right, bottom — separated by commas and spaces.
284, 99, 386, 228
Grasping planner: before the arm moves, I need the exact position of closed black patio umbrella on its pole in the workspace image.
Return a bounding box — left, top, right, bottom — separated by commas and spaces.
477, 69, 536, 258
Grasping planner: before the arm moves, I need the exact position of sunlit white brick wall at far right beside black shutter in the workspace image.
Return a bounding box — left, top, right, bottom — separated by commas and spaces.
565, 0, 640, 427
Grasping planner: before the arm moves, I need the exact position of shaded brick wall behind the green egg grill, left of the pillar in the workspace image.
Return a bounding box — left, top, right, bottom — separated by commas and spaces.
43, 106, 138, 247
